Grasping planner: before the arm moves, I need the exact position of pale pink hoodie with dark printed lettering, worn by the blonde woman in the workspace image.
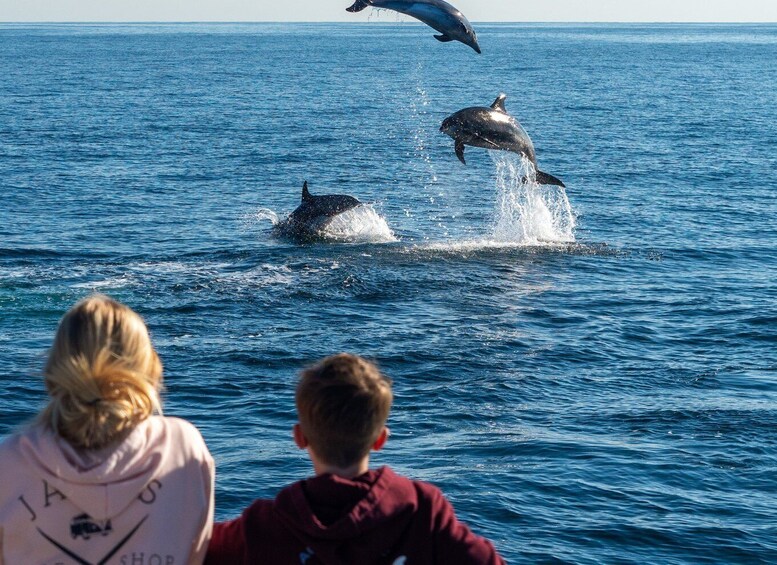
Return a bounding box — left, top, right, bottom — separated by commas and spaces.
0, 416, 214, 565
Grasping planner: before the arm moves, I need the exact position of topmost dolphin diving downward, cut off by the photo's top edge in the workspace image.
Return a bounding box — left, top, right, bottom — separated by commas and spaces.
346, 0, 480, 53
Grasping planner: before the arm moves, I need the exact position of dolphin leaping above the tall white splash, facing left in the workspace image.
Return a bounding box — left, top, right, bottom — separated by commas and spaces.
440, 94, 564, 187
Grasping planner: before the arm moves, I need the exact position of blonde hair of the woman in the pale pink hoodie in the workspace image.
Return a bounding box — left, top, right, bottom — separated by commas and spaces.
39, 294, 162, 449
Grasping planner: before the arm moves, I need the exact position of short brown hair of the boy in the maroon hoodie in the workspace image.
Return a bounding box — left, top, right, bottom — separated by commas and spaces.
296, 353, 393, 468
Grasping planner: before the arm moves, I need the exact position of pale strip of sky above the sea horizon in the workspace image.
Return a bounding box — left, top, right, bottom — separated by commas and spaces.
0, 0, 777, 22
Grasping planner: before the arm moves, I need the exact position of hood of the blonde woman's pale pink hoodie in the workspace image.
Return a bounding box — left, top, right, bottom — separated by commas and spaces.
19, 417, 170, 520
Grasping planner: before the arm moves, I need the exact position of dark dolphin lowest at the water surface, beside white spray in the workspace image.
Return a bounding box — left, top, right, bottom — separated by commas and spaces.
275, 181, 361, 240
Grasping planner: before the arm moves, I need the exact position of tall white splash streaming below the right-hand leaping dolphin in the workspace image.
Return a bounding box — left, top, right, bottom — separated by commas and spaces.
489, 151, 575, 245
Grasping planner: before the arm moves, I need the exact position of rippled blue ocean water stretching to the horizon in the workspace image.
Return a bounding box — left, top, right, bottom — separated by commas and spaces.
0, 20, 777, 563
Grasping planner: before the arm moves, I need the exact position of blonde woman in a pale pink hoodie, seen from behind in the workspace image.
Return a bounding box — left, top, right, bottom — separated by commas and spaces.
0, 295, 214, 565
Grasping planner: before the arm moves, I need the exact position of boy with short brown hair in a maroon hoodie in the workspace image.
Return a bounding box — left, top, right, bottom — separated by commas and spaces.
206, 353, 504, 565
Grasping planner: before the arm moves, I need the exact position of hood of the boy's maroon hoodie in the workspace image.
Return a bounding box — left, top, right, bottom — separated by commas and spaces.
275, 467, 418, 563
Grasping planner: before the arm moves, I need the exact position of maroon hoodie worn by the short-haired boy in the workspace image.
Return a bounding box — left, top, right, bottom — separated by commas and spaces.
205, 467, 504, 565
